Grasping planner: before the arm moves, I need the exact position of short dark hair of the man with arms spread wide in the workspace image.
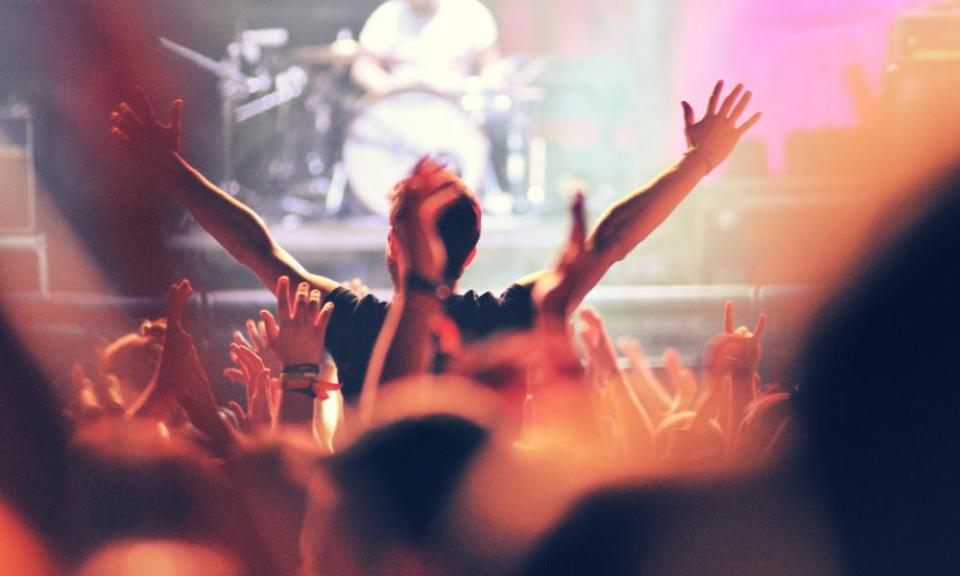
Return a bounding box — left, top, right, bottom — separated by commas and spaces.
390, 179, 481, 282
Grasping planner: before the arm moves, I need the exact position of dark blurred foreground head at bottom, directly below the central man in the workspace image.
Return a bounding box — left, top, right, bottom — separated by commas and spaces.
303, 414, 489, 575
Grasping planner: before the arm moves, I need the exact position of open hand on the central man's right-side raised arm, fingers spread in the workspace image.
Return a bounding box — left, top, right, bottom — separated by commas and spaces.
682, 80, 761, 172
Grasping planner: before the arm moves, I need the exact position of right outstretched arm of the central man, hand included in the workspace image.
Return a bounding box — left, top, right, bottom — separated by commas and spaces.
520, 81, 760, 302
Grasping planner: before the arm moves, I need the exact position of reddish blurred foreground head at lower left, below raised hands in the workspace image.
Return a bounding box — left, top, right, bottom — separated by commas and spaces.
63, 418, 267, 574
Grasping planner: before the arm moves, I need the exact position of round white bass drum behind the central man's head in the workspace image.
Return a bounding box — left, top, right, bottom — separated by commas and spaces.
343, 90, 490, 217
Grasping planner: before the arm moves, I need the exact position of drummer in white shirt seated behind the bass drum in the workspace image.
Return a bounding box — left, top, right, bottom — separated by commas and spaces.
352, 0, 499, 95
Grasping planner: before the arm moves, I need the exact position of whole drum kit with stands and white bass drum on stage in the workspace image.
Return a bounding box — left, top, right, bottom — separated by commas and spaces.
160, 28, 545, 222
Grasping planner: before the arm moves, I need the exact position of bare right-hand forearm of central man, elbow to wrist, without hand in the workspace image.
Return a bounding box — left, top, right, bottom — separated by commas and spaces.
587, 153, 707, 264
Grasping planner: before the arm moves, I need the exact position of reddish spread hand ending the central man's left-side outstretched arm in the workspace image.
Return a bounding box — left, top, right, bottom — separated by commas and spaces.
110, 86, 183, 182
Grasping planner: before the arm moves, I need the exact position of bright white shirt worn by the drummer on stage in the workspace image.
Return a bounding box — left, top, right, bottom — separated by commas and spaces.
360, 0, 497, 88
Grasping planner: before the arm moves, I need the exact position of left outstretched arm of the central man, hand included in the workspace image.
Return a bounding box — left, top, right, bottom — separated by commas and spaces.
111, 88, 337, 296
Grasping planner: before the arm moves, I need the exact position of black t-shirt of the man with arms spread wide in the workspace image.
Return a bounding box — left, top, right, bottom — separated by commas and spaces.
325, 284, 533, 399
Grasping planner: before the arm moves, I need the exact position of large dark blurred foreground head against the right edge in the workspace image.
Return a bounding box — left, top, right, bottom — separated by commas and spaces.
801, 160, 960, 574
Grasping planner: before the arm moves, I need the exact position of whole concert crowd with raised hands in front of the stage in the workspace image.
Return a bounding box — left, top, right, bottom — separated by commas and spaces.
0, 58, 960, 575
